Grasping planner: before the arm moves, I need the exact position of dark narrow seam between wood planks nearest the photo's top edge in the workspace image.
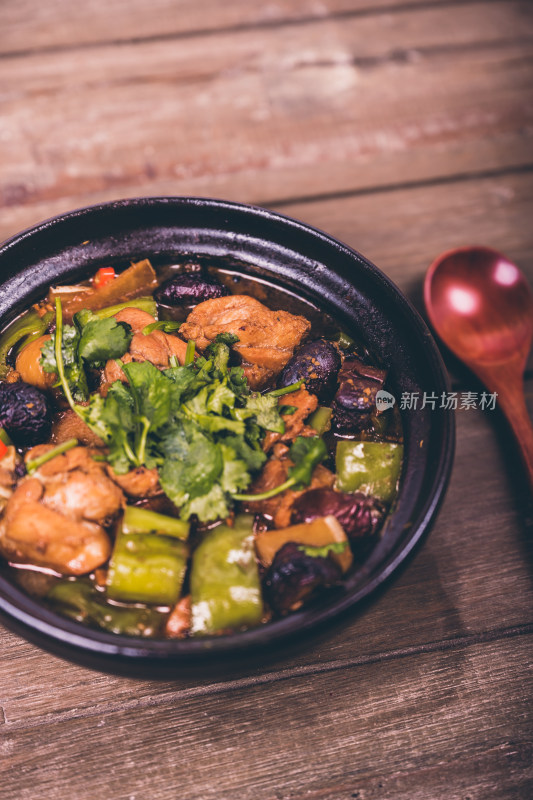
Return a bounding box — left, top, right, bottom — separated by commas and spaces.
0, 0, 524, 59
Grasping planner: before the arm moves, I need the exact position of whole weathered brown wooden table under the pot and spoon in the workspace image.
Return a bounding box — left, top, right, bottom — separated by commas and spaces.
0, 0, 533, 800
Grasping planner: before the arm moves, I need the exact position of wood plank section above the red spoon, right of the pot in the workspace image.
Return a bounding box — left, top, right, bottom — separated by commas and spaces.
280, 171, 533, 290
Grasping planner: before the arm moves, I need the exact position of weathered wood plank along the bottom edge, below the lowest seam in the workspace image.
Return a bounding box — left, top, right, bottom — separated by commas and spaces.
1, 636, 533, 800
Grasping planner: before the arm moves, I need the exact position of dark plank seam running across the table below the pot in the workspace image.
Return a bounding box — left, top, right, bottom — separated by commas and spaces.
2, 622, 533, 731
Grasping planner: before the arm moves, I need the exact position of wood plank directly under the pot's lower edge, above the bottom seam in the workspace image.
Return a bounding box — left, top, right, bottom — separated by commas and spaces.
0, 382, 533, 730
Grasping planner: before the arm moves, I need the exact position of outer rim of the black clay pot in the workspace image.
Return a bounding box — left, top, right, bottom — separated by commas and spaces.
0, 196, 455, 665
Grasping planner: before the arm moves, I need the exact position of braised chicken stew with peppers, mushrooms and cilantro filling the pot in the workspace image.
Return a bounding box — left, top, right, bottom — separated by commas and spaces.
0, 259, 403, 639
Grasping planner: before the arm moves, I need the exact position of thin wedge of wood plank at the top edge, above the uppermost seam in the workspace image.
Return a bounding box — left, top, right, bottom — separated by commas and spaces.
0, 0, 474, 53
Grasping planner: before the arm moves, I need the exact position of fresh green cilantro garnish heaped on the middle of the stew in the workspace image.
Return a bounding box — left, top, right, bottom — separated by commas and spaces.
43, 300, 320, 522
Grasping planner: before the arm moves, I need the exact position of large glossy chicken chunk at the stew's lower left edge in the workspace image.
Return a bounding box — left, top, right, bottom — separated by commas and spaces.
0, 478, 111, 575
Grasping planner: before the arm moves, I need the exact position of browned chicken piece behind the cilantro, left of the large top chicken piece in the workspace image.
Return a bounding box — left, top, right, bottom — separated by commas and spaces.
102, 308, 187, 386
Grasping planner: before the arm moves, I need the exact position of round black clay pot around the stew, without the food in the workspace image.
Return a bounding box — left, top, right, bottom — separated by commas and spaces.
0, 197, 454, 675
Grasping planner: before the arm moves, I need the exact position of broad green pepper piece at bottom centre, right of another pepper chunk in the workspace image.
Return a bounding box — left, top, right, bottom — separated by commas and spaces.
191, 514, 263, 636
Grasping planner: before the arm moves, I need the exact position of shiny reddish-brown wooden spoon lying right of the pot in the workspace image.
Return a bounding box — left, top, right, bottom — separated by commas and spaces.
424, 247, 533, 489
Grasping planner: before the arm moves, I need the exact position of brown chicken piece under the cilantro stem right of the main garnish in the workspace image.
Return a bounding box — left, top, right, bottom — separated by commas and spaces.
247, 458, 335, 528
